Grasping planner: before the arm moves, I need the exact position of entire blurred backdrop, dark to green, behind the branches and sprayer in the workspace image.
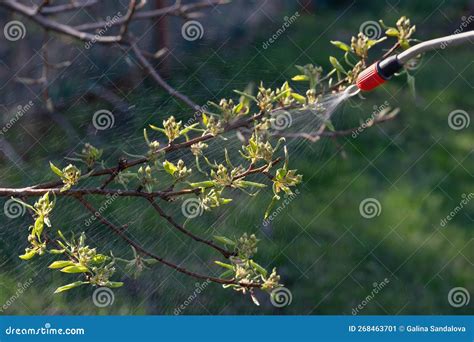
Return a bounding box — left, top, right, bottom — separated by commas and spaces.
0, 0, 474, 315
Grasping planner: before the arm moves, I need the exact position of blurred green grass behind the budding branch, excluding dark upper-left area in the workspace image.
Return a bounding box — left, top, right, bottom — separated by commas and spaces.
0, 2, 474, 314
